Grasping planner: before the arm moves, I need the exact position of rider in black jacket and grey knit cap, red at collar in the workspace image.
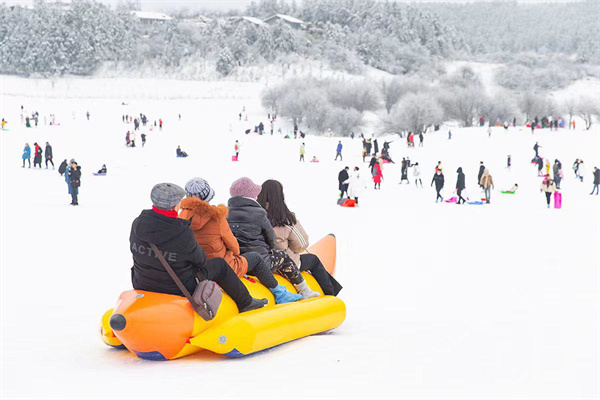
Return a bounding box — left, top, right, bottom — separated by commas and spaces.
129, 183, 267, 312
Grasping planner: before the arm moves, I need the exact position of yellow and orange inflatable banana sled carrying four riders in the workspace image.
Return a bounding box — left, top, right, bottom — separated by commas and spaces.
100, 235, 346, 361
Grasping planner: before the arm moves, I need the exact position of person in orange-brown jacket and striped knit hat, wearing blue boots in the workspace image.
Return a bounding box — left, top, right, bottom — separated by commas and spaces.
179, 178, 302, 304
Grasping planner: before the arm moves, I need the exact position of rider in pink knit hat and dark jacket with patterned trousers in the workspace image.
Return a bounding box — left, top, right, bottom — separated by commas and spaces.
227, 177, 319, 299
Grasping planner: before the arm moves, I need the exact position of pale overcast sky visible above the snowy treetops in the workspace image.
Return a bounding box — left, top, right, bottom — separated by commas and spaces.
0, 0, 581, 11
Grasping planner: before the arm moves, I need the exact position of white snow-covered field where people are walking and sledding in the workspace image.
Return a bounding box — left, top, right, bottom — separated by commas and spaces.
0, 76, 600, 399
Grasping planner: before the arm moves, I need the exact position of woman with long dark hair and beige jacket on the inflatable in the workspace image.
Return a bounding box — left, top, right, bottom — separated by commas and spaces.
257, 179, 342, 296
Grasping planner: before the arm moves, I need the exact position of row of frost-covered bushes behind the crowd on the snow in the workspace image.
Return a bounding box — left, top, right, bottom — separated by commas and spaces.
262, 67, 600, 136
